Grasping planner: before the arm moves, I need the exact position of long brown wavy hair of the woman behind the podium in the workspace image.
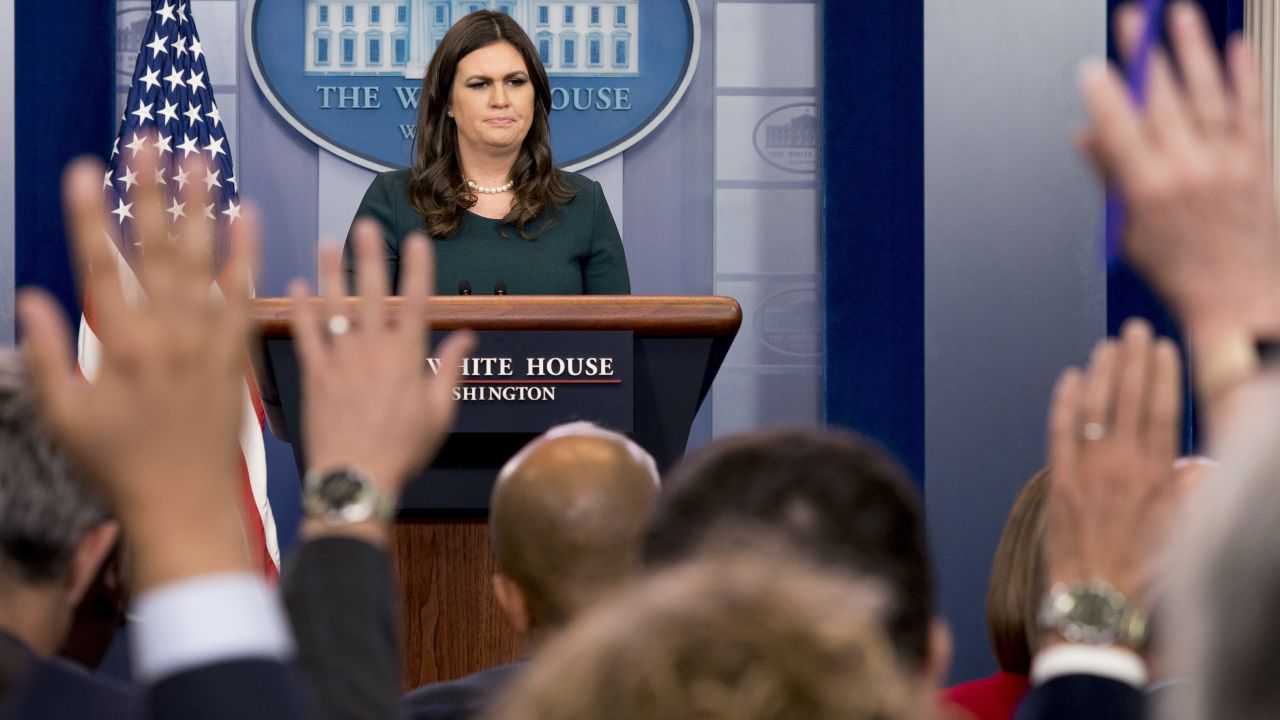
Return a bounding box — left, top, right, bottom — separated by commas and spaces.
407, 10, 576, 240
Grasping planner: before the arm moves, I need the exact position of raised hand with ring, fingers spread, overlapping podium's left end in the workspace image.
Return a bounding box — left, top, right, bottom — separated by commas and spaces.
291, 220, 475, 536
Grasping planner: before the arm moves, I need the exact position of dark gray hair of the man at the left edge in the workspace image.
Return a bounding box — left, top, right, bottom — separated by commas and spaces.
0, 348, 109, 583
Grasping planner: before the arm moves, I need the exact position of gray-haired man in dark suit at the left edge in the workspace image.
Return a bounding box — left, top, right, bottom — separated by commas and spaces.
0, 350, 138, 719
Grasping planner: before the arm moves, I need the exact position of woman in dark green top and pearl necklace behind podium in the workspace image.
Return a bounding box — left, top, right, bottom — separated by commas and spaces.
343, 10, 631, 295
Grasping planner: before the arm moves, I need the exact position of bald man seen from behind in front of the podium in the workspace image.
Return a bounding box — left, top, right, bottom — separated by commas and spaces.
404, 423, 658, 720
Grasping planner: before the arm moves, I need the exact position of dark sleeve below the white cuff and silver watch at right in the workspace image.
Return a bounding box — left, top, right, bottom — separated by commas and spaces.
1015, 675, 1147, 720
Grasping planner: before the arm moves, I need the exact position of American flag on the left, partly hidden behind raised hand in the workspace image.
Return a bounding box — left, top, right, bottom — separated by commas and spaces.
78, 0, 279, 578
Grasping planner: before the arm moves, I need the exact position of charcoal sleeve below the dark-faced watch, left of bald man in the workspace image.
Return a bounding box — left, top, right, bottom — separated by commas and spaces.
282, 538, 403, 720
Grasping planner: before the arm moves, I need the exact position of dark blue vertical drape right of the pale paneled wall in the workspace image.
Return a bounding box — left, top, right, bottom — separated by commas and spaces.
822, 0, 924, 482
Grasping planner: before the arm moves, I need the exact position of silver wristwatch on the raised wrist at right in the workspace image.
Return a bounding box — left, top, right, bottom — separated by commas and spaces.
1038, 580, 1147, 650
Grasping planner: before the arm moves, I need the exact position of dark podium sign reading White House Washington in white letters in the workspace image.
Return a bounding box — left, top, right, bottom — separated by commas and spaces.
445, 331, 635, 433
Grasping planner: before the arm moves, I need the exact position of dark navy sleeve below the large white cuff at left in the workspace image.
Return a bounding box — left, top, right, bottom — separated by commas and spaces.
146, 660, 316, 720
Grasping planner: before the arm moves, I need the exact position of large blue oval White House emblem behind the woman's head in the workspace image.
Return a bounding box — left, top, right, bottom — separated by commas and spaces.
244, 0, 700, 170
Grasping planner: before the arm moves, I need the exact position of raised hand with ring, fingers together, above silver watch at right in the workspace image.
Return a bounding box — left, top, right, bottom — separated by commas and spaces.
1044, 320, 1185, 627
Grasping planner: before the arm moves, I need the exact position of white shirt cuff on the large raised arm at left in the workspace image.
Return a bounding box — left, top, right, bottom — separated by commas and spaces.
129, 573, 293, 683
